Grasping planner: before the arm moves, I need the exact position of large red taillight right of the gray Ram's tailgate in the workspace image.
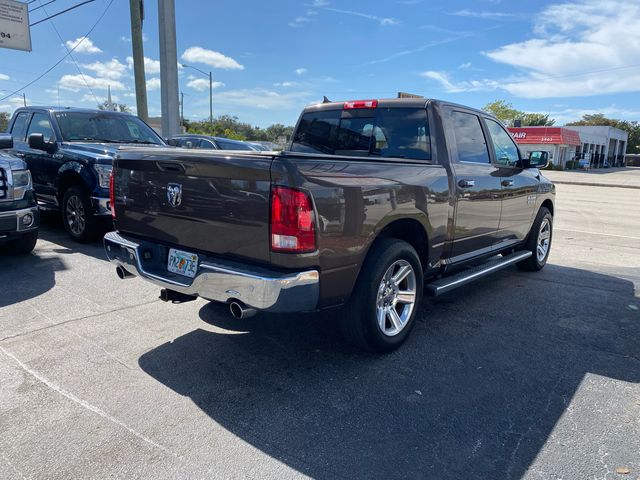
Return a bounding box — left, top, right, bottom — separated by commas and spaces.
271, 187, 316, 253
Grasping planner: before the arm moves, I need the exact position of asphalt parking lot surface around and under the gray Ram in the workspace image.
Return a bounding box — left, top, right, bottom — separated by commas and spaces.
0, 181, 640, 479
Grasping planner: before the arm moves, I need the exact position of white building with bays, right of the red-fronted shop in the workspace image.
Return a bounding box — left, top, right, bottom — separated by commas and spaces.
565, 126, 629, 168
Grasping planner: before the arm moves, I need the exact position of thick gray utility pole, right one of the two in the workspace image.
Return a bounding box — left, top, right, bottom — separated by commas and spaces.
158, 0, 180, 138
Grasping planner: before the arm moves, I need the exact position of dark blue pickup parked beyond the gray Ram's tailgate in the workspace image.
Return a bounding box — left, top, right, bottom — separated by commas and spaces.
8, 107, 165, 242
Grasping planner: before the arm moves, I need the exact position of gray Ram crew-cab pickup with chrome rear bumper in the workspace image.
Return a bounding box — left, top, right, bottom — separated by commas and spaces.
104, 99, 555, 352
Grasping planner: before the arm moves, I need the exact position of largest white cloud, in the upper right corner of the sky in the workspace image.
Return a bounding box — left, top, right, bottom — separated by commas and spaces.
485, 0, 640, 98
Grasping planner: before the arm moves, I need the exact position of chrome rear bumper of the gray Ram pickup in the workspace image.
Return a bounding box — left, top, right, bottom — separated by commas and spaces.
104, 232, 320, 312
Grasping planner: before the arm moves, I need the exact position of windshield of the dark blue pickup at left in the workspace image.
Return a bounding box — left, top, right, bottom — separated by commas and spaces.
56, 112, 163, 145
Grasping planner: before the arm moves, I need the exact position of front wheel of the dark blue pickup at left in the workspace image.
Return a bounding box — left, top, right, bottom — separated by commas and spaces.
62, 187, 99, 242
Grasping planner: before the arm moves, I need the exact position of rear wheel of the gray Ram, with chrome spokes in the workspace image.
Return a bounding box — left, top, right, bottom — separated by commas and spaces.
341, 239, 423, 352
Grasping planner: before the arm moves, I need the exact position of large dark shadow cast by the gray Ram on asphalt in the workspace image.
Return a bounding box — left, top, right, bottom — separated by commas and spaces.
139, 265, 640, 479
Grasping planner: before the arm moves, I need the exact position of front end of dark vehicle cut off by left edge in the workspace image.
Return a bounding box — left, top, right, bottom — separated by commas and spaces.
0, 134, 40, 253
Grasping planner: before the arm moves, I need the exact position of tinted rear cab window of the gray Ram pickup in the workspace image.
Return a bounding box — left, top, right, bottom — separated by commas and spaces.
291, 107, 431, 161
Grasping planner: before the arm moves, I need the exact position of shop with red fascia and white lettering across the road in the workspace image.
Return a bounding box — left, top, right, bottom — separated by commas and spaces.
509, 127, 582, 168
